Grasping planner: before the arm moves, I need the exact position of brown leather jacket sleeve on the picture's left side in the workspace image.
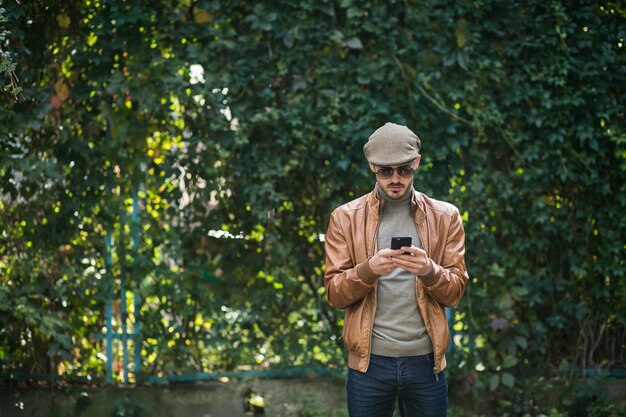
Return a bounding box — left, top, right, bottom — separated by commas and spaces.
324, 210, 376, 309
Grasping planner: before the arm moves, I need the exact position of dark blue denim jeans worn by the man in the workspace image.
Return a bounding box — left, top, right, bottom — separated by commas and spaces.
346, 353, 448, 417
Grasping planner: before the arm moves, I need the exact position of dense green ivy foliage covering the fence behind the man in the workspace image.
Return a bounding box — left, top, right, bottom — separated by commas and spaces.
0, 0, 626, 415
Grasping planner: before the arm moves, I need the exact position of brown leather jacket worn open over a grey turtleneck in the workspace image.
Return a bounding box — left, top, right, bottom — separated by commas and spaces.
324, 189, 468, 372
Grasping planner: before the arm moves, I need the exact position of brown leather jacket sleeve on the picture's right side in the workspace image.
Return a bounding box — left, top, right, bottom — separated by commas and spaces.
420, 210, 469, 307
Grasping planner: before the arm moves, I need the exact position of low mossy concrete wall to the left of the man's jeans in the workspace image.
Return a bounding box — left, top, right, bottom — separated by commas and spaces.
0, 378, 347, 417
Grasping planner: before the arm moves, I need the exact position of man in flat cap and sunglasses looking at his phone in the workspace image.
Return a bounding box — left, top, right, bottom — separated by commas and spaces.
324, 123, 468, 417
